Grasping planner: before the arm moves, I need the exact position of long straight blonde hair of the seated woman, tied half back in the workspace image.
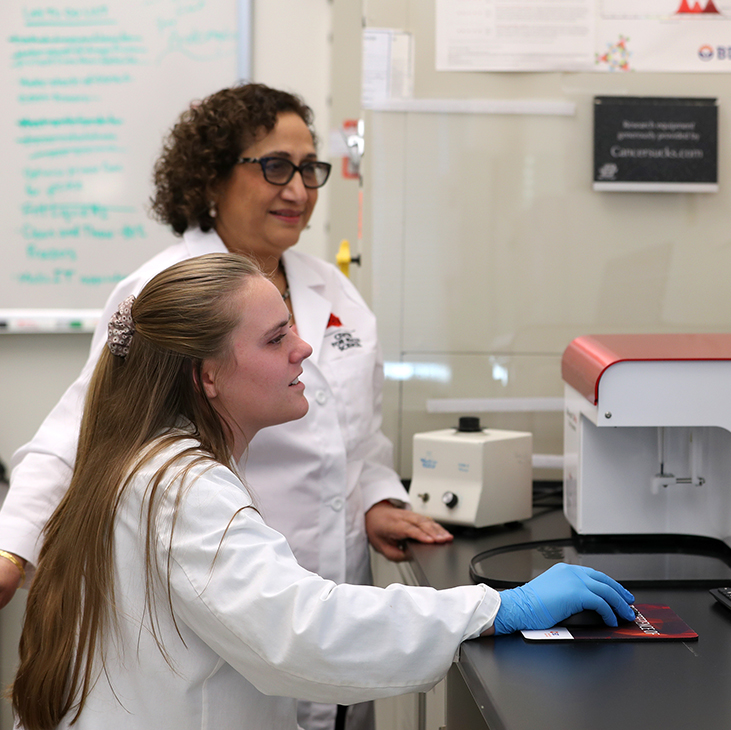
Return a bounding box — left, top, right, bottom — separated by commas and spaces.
12, 254, 260, 730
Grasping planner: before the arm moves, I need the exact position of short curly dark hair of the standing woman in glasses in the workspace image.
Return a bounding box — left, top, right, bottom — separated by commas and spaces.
150, 84, 315, 236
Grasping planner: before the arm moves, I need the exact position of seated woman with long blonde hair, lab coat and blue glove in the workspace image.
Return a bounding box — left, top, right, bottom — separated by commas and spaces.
12, 254, 632, 730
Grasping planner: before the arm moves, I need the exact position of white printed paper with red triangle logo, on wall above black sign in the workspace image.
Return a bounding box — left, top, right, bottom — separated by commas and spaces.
435, 0, 731, 73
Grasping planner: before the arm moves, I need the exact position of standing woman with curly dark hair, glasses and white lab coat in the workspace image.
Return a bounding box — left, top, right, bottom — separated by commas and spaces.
0, 84, 451, 730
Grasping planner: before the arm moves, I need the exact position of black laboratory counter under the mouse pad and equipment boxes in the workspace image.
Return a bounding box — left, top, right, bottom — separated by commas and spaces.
409, 510, 731, 730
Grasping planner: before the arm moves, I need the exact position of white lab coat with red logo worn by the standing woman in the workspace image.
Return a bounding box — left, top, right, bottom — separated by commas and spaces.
0, 230, 408, 730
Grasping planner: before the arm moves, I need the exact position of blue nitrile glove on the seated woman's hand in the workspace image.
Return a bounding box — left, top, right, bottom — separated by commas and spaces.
495, 563, 635, 634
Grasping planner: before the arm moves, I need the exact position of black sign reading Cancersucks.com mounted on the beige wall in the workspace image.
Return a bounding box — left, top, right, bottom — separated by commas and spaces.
594, 96, 718, 192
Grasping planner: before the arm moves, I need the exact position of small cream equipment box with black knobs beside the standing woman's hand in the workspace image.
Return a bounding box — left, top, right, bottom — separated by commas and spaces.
409, 417, 533, 527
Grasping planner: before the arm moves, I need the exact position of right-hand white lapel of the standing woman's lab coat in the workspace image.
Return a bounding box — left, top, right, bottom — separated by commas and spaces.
282, 251, 332, 362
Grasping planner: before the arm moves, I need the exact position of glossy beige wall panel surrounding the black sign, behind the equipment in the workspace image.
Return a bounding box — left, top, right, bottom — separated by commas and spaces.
363, 0, 731, 479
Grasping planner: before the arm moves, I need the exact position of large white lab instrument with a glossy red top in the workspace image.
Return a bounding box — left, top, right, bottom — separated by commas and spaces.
562, 333, 731, 545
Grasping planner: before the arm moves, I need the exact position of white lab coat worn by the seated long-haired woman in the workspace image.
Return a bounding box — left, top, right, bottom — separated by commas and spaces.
44, 439, 500, 730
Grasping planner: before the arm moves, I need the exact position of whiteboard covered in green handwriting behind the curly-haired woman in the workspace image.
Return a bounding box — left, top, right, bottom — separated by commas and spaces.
0, 0, 238, 310
